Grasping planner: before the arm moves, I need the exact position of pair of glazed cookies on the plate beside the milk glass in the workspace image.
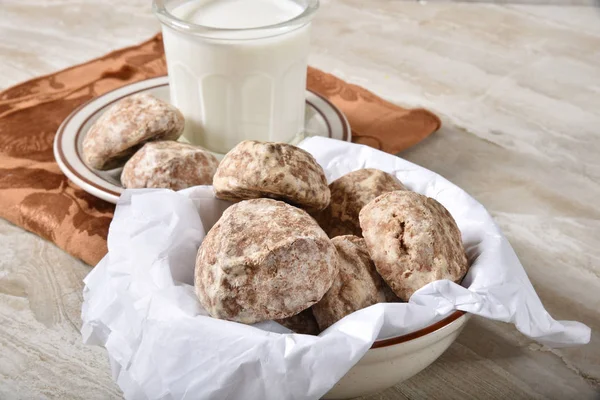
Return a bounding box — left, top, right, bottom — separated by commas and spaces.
82, 93, 219, 190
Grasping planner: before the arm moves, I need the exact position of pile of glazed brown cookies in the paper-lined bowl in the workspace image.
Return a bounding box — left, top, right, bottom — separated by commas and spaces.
195, 141, 468, 334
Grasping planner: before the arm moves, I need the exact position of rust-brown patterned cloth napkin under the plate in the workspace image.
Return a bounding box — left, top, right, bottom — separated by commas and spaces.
0, 34, 440, 265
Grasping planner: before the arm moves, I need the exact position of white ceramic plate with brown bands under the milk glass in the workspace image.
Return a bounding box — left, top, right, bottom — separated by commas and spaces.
54, 76, 351, 203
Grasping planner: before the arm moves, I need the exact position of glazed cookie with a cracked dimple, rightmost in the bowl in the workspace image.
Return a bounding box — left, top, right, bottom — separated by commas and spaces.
360, 191, 468, 301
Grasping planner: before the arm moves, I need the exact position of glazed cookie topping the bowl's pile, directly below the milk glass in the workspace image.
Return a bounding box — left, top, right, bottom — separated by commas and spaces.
213, 140, 330, 210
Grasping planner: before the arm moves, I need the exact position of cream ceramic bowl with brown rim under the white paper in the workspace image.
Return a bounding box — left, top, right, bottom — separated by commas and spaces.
323, 311, 471, 399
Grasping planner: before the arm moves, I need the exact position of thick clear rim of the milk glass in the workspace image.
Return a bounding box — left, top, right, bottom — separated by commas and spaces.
152, 0, 319, 40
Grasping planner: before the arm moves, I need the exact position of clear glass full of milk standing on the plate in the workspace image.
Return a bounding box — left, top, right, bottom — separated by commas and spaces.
154, 0, 319, 154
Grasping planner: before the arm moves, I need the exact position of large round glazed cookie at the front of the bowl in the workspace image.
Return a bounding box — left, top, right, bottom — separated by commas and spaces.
195, 199, 337, 324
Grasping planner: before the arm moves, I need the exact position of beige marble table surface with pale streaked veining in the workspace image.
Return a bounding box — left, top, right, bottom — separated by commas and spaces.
0, 0, 600, 400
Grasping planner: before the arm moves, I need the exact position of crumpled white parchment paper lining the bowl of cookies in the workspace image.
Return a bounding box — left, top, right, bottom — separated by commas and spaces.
82, 138, 590, 399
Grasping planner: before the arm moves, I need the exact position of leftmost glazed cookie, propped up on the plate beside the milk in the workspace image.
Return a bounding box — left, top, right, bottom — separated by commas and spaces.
83, 94, 184, 170
